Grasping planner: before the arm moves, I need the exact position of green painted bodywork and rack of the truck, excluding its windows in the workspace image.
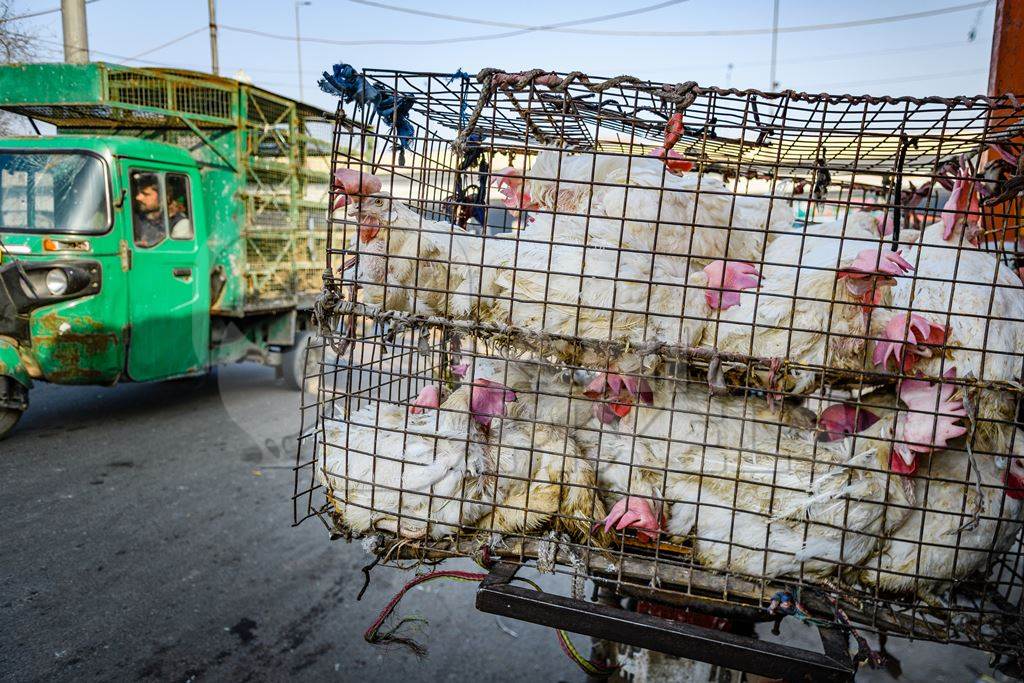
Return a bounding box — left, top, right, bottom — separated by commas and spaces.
0, 63, 330, 384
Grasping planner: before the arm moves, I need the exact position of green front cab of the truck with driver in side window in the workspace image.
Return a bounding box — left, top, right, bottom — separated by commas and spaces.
0, 136, 210, 384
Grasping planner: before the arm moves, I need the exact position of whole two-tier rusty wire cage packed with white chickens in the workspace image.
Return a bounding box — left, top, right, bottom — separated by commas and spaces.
295, 70, 1024, 653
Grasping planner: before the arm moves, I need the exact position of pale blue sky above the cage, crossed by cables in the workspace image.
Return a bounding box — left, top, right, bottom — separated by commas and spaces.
13, 0, 994, 106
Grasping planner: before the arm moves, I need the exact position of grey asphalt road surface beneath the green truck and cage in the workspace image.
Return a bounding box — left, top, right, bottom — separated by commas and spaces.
0, 366, 1007, 683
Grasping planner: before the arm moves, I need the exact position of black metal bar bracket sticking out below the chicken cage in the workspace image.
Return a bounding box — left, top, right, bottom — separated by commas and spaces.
476, 562, 857, 681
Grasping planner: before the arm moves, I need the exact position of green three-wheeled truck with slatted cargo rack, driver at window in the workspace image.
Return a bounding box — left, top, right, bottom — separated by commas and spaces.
0, 63, 332, 436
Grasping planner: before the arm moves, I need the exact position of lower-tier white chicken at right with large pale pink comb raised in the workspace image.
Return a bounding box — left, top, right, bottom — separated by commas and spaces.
669, 370, 966, 577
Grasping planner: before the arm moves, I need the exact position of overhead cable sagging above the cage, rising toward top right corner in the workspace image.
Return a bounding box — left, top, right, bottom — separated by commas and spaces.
349, 0, 992, 37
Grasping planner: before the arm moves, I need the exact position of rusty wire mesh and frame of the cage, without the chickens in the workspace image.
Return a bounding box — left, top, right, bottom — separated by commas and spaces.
294, 70, 1024, 656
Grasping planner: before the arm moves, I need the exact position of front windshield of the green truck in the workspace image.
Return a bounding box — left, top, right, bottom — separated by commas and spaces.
0, 152, 111, 233
